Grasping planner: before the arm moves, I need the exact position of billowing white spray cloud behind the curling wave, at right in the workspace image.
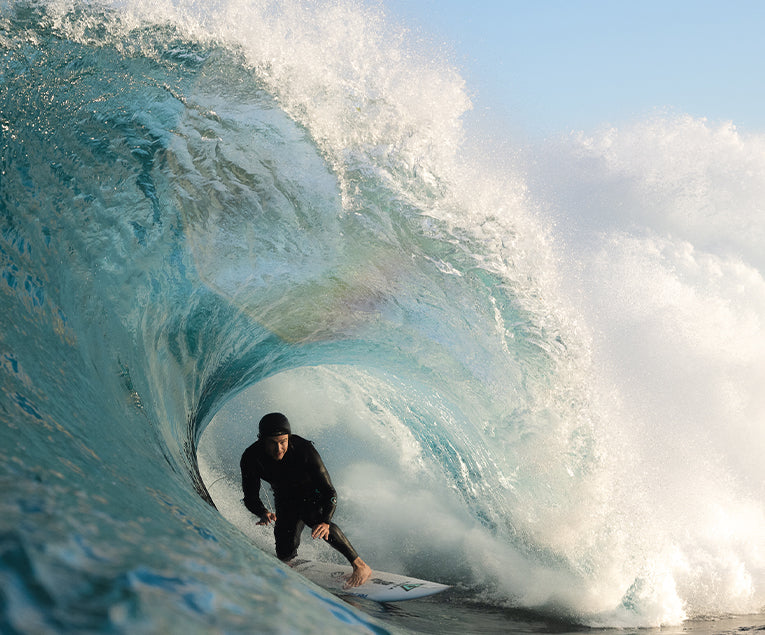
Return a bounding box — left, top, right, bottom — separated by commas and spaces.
545, 117, 765, 615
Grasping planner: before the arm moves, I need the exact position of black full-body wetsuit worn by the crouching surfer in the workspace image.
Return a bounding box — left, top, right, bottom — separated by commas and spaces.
239, 434, 358, 562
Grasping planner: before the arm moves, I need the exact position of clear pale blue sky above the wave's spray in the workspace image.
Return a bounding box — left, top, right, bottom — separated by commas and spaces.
383, 0, 765, 136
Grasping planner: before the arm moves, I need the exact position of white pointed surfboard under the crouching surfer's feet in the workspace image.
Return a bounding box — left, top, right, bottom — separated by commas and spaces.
289, 558, 449, 602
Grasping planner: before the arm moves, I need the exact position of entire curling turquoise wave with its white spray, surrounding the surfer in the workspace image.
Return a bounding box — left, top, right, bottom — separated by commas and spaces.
0, 0, 765, 633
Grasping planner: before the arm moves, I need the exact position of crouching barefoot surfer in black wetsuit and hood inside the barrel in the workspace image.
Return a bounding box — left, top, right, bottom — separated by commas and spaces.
239, 412, 372, 587
